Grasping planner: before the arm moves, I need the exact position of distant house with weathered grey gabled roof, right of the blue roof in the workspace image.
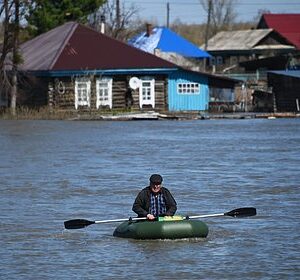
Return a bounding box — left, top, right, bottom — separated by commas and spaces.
203, 29, 295, 73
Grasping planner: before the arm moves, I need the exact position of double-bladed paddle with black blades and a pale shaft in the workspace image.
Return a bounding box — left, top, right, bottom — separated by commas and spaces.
64, 207, 256, 229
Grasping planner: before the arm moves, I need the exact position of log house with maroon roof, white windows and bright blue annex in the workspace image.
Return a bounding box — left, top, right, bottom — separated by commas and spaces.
14, 22, 235, 112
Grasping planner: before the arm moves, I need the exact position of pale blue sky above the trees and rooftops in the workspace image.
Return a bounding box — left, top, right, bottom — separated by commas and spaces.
120, 0, 300, 25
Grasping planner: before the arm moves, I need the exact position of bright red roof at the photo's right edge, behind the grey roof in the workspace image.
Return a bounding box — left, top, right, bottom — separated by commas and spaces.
257, 14, 300, 49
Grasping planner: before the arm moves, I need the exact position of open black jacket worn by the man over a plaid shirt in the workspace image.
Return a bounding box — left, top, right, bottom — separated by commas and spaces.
132, 186, 177, 217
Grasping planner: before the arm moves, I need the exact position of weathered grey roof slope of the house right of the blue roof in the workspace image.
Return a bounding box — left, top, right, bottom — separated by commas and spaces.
207, 29, 272, 51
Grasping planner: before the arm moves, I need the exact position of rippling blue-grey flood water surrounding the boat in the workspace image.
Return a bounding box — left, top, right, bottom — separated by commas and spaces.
0, 119, 300, 280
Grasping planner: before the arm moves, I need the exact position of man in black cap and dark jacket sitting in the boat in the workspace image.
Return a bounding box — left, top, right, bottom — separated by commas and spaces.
132, 174, 177, 220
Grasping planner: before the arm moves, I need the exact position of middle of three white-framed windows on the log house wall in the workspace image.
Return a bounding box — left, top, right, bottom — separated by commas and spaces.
96, 78, 112, 109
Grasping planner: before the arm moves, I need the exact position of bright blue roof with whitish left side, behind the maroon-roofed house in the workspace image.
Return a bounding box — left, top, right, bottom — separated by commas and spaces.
128, 27, 210, 58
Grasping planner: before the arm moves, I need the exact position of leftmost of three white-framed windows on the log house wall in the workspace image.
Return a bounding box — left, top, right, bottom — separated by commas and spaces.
75, 78, 91, 109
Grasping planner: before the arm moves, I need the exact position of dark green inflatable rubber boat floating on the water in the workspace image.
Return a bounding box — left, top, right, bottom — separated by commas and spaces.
113, 218, 208, 239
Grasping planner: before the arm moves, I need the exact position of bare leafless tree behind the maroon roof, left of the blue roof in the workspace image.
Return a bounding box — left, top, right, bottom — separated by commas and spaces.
90, 0, 138, 41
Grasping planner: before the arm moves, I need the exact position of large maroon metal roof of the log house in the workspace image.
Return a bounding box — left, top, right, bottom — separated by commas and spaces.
20, 22, 177, 71
